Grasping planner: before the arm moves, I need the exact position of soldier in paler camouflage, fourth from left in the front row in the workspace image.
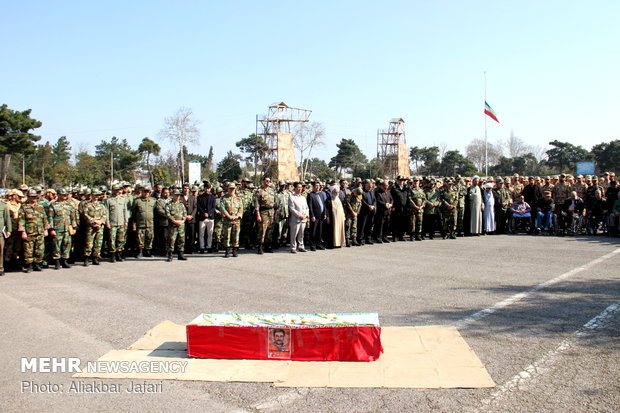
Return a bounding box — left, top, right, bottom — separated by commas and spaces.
105, 184, 129, 262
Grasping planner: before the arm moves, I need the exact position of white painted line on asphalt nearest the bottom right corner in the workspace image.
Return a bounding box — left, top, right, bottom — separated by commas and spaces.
476, 302, 620, 412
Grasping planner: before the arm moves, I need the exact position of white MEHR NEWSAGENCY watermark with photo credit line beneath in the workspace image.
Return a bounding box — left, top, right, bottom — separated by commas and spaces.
20, 357, 187, 394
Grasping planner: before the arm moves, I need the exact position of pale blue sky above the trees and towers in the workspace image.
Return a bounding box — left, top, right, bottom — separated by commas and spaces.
0, 0, 620, 161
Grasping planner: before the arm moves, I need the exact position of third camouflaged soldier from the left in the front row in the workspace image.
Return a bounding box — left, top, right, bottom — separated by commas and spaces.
82, 189, 107, 267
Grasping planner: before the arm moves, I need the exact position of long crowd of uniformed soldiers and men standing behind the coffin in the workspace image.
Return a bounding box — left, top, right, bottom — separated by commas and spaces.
0, 173, 620, 274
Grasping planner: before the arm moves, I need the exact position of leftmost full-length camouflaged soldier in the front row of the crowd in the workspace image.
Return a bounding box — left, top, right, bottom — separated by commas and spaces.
18, 189, 48, 273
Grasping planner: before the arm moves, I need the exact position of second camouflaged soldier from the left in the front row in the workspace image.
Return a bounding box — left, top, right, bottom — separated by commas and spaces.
47, 188, 78, 270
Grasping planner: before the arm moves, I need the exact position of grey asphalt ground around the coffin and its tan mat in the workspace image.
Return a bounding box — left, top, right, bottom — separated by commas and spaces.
0, 235, 620, 413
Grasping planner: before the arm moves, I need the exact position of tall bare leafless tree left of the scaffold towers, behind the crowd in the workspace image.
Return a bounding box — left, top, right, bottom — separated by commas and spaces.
157, 107, 200, 183
